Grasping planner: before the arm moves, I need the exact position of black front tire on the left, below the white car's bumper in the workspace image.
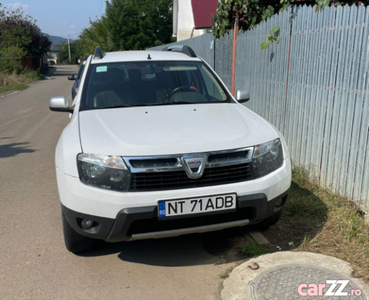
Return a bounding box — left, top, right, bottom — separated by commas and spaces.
62, 210, 97, 253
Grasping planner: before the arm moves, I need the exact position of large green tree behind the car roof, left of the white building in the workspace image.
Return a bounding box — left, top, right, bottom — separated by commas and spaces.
76, 0, 173, 58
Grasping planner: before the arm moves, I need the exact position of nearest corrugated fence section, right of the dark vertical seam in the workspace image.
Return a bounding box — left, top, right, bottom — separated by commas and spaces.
279, 6, 369, 204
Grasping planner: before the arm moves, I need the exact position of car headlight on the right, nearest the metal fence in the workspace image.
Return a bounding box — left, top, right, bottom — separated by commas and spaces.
252, 139, 283, 178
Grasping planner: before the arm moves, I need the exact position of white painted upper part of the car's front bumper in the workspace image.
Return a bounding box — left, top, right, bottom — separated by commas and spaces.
56, 159, 291, 219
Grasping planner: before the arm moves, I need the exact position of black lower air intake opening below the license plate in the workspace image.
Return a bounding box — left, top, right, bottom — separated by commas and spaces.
127, 207, 256, 236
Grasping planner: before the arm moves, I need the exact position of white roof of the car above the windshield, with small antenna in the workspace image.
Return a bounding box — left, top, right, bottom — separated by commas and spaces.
91, 50, 201, 64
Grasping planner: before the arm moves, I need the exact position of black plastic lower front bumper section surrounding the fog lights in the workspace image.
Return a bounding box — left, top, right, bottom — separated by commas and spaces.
62, 190, 289, 242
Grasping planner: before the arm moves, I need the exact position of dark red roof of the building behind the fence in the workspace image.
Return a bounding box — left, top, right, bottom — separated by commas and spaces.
191, 0, 218, 29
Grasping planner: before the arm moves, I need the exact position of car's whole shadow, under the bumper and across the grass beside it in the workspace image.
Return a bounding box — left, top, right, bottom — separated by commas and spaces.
75, 179, 328, 267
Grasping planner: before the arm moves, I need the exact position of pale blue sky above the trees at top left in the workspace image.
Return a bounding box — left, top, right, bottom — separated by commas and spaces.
0, 0, 105, 39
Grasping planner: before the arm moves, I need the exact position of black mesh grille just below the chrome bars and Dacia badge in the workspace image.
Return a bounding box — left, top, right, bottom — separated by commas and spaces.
130, 163, 254, 192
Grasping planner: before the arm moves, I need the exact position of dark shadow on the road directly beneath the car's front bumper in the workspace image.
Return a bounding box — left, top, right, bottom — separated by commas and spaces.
81, 228, 246, 267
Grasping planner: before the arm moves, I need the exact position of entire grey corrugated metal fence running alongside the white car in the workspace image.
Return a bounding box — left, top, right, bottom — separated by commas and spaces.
148, 6, 369, 207
